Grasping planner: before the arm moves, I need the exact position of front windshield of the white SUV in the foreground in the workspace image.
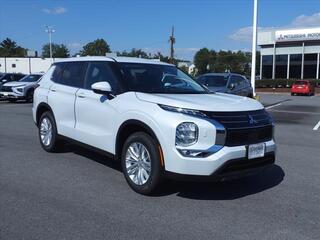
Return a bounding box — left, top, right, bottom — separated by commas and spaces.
119, 63, 207, 94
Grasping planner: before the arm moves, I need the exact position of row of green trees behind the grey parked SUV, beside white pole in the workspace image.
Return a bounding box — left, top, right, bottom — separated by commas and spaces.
194, 48, 260, 75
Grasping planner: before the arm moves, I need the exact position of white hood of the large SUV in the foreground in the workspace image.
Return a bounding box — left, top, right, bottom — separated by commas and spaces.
136, 93, 264, 112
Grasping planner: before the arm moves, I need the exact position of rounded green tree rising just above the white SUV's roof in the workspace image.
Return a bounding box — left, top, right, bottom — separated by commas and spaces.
80, 39, 111, 56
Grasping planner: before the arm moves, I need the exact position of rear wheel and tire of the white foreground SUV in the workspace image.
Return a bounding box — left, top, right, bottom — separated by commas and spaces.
38, 111, 62, 152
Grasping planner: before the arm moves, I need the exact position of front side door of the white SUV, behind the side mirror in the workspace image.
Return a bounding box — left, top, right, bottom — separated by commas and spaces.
75, 61, 119, 152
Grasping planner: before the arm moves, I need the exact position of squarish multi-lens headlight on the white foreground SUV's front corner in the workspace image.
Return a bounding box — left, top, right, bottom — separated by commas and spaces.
176, 122, 199, 147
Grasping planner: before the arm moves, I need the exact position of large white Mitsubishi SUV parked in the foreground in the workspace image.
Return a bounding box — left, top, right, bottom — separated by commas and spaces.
33, 57, 275, 194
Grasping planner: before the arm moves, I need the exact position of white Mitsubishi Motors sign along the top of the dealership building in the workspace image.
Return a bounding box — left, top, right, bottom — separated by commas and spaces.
275, 28, 320, 42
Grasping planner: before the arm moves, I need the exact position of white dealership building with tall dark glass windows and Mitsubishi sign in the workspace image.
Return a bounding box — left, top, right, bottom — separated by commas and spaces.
258, 27, 320, 79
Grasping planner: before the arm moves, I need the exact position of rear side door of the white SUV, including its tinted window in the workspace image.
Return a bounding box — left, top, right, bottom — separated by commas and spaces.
48, 62, 86, 138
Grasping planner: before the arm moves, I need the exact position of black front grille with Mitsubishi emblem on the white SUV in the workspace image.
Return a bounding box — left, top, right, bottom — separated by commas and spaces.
204, 109, 273, 146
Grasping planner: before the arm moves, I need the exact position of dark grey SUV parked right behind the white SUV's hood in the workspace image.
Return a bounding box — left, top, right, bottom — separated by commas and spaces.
197, 73, 253, 98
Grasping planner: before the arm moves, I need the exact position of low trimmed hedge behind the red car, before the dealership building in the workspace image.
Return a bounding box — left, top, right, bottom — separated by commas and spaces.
256, 79, 320, 88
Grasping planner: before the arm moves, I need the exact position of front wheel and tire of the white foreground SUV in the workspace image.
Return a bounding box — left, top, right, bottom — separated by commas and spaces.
121, 132, 163, 195
